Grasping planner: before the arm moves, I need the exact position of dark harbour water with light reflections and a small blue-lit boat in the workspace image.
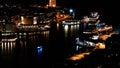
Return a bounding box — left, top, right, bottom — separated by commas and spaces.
0, 24, 79, 68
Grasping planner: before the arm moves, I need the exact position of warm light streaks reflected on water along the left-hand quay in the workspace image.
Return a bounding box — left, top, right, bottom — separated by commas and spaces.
0, 31, 49, 54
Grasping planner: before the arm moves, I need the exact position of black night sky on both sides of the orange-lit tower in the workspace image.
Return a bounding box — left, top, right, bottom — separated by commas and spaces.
0, 0, 120, 23
